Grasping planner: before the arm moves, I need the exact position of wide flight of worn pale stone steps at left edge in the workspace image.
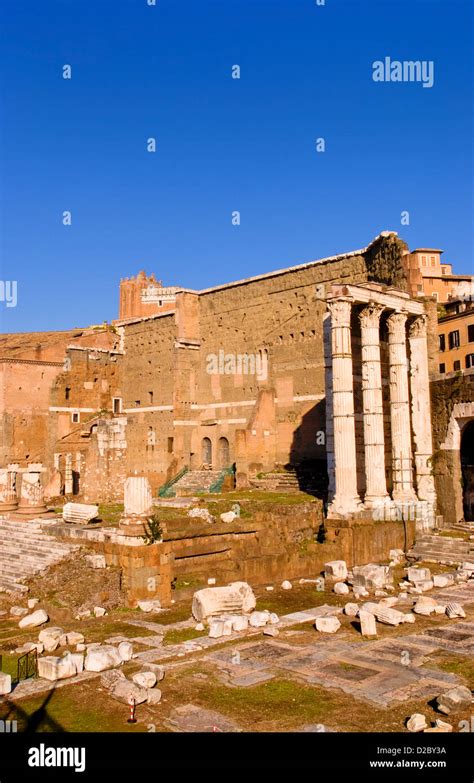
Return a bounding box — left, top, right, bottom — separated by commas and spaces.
0, 517, 79, 592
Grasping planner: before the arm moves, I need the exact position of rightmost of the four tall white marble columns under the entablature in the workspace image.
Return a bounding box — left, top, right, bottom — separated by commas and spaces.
408, 315, 436, 506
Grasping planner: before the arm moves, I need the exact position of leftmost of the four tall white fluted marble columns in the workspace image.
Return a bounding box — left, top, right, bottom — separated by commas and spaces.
328, 297, 362, 515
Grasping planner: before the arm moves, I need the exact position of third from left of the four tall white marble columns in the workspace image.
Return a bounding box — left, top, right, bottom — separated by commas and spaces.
387, 312, 416, 501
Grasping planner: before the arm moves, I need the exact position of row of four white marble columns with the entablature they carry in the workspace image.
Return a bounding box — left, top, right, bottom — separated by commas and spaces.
326, 284, 436, 527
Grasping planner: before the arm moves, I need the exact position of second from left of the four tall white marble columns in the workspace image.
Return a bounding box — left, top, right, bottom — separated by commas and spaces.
359, 302, 390, 508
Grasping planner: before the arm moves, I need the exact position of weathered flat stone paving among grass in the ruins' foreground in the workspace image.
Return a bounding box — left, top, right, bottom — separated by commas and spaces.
2, 582, 474, 708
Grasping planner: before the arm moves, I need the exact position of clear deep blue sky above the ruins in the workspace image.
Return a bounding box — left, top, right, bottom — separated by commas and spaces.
0, 0, 473, 332
